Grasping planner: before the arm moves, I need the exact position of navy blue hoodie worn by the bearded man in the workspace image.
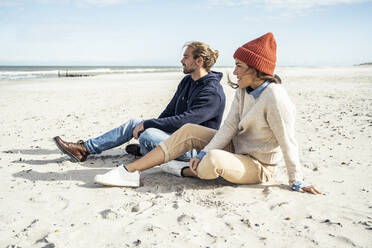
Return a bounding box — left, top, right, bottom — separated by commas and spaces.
143, 71, 225, 133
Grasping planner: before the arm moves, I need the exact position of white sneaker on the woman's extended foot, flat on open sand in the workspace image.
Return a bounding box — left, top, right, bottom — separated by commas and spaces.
94, 165, 140, 187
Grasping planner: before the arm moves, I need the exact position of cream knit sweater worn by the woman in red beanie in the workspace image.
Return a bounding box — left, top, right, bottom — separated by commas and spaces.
203, 83, 303, 184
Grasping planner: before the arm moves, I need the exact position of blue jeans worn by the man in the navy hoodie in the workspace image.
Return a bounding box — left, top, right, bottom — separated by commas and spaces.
84, 119, 196, 161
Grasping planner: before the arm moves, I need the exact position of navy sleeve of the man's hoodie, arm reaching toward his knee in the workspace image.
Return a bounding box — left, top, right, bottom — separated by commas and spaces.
144, 90, 223, 133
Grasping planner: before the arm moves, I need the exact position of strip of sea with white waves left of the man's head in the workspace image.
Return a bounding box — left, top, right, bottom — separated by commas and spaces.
0, 66, 182, 81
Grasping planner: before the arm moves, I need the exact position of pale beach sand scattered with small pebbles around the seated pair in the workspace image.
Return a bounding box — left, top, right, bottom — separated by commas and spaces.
0, 66, 372, 248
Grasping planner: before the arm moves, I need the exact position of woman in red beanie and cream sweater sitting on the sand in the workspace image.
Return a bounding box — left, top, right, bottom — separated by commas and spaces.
95, 33, 320, 194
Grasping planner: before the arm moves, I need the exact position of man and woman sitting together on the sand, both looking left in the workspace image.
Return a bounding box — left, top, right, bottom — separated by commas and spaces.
54, 33, 320, 194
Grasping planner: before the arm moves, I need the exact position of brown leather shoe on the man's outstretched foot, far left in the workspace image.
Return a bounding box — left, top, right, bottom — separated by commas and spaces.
53, 136, 89, 162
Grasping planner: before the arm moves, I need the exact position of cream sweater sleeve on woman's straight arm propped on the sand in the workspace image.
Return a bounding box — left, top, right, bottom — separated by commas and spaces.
267, 88, 303, 185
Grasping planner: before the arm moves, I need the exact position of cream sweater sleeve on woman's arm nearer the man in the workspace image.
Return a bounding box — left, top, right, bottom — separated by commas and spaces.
203, 90, 241, 152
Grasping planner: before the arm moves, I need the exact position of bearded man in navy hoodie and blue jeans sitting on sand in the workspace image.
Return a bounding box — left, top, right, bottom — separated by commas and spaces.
53, 42, 225, 162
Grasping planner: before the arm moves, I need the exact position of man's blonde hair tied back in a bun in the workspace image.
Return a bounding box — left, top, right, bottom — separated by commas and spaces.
183, 41, 218, 72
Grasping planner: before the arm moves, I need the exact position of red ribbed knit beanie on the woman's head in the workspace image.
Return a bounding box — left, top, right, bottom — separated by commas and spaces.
234, 33, 276, 76
